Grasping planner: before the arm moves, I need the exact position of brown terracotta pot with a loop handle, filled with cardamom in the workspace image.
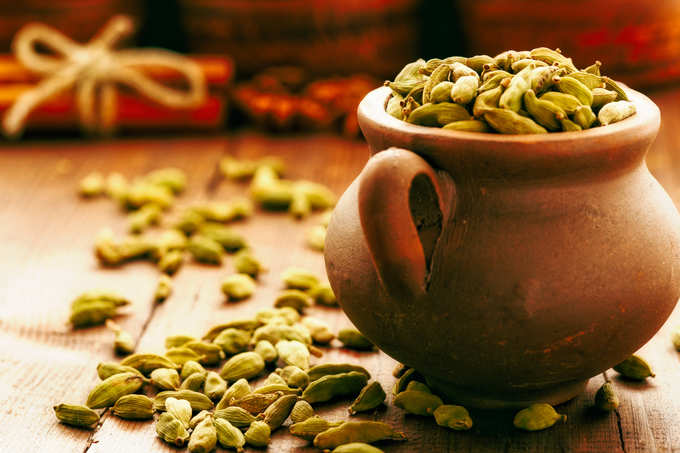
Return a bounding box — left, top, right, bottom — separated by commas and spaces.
326, 88, 680, 407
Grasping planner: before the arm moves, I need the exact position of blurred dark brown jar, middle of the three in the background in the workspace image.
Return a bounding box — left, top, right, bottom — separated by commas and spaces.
180, 0, 419, 77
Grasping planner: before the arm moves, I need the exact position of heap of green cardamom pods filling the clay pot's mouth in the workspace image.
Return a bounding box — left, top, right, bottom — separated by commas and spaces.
385, 47, 635, 134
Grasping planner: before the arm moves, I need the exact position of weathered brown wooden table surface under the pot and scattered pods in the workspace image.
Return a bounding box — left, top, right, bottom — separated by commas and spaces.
0, 86, 680, 453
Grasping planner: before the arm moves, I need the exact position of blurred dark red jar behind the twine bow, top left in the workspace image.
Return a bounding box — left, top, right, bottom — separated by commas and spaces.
0, 0, 142, 52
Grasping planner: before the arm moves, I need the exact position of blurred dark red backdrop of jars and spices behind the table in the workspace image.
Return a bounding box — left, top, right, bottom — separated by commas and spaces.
0, 0, 680, 137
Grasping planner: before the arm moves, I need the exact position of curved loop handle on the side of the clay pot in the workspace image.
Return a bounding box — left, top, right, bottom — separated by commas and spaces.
358, 148, 454, 299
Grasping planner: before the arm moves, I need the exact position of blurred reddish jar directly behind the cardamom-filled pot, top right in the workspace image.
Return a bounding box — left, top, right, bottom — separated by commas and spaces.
457, 0, 680, 87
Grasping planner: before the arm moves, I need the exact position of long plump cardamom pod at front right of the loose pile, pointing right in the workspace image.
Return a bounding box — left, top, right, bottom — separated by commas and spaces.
314, 421, 406, 449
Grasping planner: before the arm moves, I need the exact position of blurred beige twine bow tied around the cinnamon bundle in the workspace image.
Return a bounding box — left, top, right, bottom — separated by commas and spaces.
2, 16, 206, 138
